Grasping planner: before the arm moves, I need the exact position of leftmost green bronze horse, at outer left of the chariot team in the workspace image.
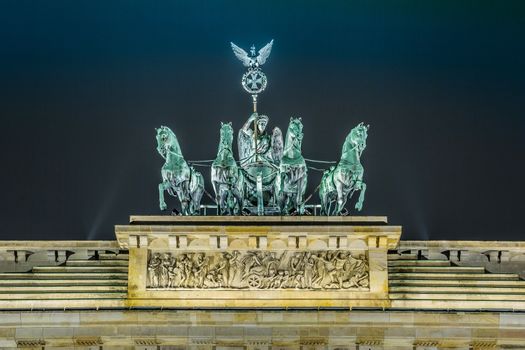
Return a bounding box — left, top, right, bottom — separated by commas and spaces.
156, 126, 204, 215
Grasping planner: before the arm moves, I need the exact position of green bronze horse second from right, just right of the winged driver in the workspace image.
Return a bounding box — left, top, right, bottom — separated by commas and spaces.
275, 117, 308, 215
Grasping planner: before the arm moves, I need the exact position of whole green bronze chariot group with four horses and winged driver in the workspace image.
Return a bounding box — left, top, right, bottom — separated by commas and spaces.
157, 40, 369, 215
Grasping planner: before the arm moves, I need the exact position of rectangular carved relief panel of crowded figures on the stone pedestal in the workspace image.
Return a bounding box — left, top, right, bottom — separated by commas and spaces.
147, 250, 369, 291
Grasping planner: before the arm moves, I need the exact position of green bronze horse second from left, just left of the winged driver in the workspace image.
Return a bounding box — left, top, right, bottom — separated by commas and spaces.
211, 122, 244, 215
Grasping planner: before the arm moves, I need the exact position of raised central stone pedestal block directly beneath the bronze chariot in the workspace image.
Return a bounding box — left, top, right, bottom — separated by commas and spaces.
115, 216, 401, 308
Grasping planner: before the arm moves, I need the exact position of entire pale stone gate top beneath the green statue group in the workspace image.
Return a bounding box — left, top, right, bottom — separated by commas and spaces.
0, 217, 525, 350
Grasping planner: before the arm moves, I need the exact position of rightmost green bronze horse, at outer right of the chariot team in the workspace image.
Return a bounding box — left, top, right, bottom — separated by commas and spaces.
319, 122, 370, 215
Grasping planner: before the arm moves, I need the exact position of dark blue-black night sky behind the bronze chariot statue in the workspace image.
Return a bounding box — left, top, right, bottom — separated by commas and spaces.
0, 0, 525, 240
